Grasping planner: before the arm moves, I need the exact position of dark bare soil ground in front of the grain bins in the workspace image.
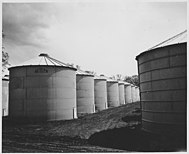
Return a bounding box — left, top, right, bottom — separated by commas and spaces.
2, 103, 186, 153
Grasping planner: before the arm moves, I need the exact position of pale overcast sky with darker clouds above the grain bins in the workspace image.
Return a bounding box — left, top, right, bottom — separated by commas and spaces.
2, 0, 187, 76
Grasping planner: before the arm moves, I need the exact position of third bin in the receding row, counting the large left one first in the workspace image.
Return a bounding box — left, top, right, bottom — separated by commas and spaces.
94, 76, 108, 112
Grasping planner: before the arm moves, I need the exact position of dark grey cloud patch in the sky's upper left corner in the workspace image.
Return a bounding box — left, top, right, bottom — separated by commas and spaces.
2, 3, 54, 47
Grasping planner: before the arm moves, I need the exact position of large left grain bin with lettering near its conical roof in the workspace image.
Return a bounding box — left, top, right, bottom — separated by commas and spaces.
9, 54, 77, 121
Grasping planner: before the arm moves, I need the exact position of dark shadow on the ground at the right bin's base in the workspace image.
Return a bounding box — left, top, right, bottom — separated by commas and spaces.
89, 122, 186, 152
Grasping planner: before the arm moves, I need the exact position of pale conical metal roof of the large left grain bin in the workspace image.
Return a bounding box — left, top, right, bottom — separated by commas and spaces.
8, 53, 76, 69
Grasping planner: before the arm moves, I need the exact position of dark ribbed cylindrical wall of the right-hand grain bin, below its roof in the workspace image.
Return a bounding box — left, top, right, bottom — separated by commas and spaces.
136, 39, 187, 135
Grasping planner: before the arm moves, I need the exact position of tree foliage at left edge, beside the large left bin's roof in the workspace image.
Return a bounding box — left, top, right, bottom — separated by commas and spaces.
2, 32, 10, 72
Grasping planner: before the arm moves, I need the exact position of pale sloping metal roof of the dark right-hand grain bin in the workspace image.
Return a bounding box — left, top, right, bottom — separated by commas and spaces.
148, 30, 187, 50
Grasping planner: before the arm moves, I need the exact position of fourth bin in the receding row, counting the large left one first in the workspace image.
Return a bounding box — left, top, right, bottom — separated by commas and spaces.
107, 79, 120, 108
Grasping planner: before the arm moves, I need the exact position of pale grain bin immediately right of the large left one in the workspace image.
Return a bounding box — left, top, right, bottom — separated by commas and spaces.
76, 70, 95, 116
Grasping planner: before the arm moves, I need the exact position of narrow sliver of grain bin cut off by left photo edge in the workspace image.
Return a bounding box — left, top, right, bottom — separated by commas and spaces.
2, 76, 9, 117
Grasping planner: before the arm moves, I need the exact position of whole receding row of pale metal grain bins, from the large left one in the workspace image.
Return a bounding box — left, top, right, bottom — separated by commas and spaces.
4, 54, 138, 121
